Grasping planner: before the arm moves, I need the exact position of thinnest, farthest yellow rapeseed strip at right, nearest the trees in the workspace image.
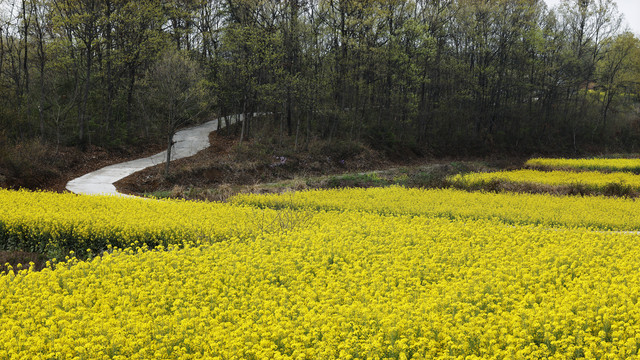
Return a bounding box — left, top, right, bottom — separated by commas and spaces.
525, 158, 640, 174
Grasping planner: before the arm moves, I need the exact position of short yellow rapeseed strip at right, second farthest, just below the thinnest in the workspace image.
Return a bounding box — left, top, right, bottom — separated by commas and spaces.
449, 170, 640, 191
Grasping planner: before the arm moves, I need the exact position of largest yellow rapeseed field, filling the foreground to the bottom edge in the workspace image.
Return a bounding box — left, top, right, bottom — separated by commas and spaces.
0, 211, 640, 359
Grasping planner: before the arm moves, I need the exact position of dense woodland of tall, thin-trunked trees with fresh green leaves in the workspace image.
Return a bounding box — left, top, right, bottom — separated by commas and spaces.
0, 0, 640, 154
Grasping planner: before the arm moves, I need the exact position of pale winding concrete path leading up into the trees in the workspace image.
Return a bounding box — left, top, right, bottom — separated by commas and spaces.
67, 115, 243, 196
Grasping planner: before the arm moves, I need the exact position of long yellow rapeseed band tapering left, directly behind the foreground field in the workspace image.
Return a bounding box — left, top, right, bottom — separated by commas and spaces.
232, 186, 640, 230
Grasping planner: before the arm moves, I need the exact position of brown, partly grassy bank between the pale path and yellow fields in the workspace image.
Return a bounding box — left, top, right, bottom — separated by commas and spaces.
115, 131, 522, 201
